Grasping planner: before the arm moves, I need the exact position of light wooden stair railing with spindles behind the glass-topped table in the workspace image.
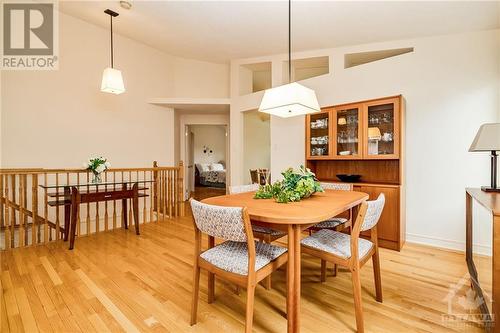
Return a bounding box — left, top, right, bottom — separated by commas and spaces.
0, 162, 184, 250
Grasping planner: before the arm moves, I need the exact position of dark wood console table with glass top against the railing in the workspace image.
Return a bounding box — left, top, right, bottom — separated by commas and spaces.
40, 180, 154, 250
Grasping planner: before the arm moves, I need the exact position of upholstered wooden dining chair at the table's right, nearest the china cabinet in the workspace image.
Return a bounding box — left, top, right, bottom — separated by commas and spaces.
301, 193, 385, 332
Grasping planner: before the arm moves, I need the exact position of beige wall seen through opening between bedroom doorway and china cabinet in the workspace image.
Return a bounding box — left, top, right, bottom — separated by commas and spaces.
243, 111, 271, 184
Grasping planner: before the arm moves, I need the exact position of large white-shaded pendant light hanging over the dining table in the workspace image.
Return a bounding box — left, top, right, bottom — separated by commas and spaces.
259, 0, 321, 118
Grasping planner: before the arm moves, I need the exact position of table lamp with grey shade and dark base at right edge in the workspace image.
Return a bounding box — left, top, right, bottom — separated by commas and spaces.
469, 123, 500, 192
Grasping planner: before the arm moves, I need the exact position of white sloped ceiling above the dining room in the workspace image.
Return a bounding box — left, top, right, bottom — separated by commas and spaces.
59, 1, 500, 63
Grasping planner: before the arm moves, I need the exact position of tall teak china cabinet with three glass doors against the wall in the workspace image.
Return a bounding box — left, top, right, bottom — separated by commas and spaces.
306, 95, 405, 251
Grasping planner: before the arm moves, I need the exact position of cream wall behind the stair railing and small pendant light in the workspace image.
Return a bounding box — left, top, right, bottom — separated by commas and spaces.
1, 13, 229, 168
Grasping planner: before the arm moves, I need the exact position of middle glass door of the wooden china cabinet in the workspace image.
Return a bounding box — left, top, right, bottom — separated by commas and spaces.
335, 106, 361, 158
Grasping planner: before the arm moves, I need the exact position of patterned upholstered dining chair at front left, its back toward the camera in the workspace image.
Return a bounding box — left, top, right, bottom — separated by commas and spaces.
190, 199, 288, 333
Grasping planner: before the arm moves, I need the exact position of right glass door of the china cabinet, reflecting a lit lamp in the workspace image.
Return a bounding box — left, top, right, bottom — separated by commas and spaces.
365, 100, 398, 158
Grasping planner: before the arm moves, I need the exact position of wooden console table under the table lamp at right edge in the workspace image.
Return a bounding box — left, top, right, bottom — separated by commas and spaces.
465, 188, 500, 333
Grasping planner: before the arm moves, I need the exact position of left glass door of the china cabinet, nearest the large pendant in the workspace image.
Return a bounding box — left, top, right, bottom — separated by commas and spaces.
308, 111, 330, 158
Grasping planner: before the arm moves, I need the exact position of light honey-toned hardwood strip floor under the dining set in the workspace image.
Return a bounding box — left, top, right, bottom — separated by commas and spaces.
0, 205, 480, 333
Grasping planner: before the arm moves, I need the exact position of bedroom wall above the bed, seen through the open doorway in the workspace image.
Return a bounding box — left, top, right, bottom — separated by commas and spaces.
189, 125, 226, 165
